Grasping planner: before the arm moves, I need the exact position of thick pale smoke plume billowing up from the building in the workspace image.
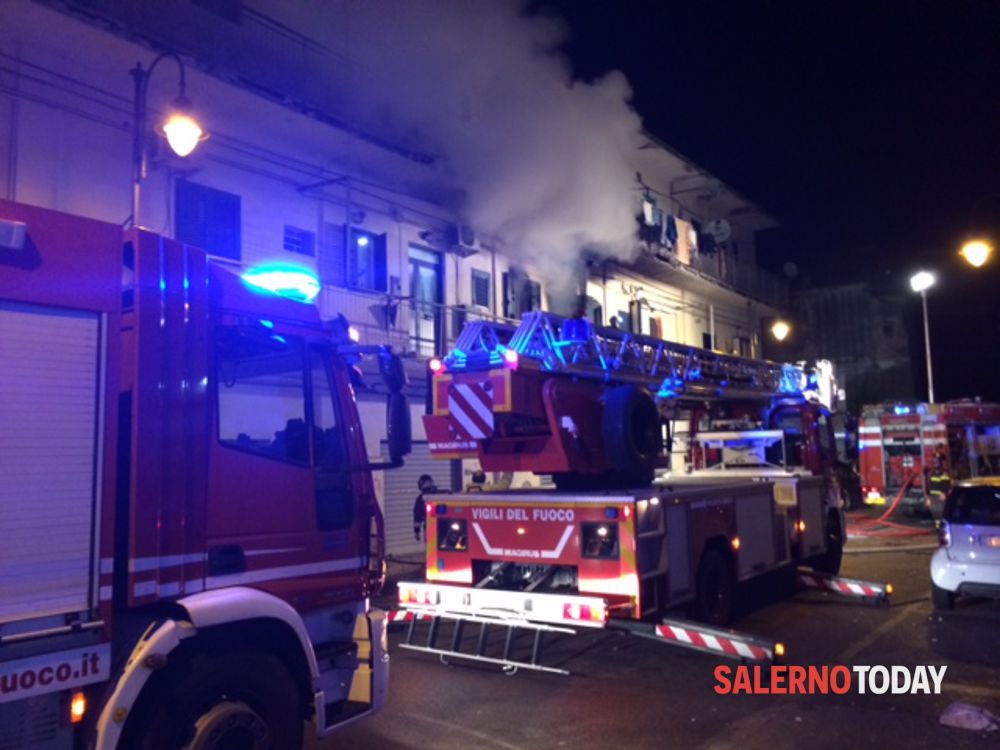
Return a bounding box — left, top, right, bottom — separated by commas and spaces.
268, 0, 642, 306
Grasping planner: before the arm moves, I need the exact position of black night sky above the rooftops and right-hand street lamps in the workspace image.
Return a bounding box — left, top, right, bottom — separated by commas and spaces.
535, 0, 1000, 400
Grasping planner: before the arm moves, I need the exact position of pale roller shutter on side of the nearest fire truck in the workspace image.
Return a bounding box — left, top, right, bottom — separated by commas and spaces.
0, 300, 102, 623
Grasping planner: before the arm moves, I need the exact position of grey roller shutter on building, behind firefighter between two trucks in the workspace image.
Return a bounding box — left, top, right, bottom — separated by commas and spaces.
382, 442, 453, 556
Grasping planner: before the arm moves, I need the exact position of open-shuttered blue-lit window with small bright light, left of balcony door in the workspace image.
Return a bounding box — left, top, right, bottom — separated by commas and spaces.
319, 223, 388, 292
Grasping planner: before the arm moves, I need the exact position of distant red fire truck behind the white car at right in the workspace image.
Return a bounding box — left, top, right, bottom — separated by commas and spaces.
858, 401, 1000, 506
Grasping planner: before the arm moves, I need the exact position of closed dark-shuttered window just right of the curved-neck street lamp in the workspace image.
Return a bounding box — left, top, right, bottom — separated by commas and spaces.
174, 180, 240, 260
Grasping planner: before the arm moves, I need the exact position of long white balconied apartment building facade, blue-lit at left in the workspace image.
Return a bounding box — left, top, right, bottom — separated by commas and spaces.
0, 0, 788, 553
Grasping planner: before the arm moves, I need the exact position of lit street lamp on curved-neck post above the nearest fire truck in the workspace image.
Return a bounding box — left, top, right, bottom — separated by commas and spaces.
130, 52, 208, 227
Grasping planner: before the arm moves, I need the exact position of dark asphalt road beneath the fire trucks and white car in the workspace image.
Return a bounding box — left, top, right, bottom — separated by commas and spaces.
323, 537, 1000, 750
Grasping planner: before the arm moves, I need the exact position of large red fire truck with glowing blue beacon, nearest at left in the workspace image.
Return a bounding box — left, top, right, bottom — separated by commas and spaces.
0, 202, 409, 748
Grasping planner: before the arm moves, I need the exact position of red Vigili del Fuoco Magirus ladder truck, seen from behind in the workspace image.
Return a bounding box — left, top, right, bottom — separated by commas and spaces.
399, 312, 868, 668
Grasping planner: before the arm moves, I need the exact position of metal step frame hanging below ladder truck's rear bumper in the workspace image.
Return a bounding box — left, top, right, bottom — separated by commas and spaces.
392, 607, 577, 675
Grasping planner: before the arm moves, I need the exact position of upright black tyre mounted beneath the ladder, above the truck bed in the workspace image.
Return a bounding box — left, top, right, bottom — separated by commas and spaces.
602, 385, 662, 485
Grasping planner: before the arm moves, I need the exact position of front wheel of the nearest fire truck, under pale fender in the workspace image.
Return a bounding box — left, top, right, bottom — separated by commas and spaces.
123, 651, 304, 750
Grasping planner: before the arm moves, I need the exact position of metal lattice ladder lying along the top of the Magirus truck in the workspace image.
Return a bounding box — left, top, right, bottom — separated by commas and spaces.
444, 311, 807, 406
